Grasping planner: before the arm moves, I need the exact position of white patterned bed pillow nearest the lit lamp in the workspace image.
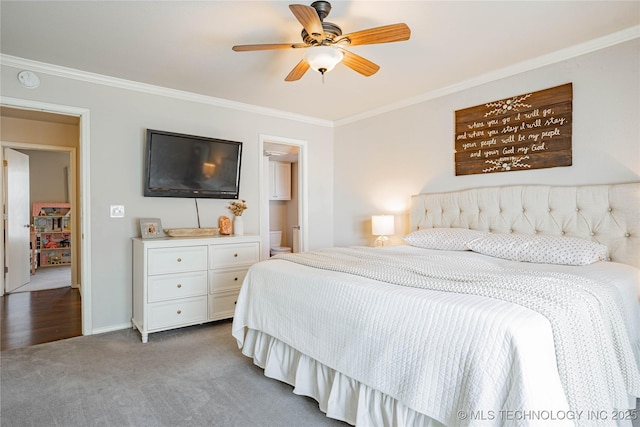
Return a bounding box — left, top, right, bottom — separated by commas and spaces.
403, 228, 487, 251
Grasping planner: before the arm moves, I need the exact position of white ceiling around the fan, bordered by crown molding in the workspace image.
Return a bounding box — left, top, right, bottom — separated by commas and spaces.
0, 0, 640, 120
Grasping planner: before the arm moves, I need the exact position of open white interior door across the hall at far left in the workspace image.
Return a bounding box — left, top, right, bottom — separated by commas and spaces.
4, 148, 31, 292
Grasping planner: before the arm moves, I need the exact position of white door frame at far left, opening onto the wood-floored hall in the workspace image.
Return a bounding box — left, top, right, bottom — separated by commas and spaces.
0, 97, 93, 335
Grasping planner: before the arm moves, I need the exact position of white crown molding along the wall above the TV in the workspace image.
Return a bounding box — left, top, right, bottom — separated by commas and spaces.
0, 54, 333, 127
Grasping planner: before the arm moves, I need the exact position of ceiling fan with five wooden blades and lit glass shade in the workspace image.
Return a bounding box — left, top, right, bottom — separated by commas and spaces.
232, 1, 411, 82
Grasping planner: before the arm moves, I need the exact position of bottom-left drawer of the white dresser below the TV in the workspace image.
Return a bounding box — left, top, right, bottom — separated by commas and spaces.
147, 295, 207, 330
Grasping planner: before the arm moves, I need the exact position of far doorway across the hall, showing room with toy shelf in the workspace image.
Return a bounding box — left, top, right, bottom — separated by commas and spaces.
4, 148, 74, 293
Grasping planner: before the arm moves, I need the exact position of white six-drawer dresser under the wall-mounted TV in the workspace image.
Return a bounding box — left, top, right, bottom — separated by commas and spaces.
131, 235, 260, 342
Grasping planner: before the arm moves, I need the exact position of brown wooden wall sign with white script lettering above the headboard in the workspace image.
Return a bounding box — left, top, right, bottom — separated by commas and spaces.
455, 83, 573, 175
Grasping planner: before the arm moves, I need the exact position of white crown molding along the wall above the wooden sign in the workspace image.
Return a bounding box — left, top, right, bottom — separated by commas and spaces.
334, 25, 640, 127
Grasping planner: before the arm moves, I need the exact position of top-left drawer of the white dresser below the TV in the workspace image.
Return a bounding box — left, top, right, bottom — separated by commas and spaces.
147, 246, 207, 274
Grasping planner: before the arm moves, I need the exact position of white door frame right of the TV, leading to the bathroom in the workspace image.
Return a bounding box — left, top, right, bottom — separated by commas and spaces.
258, 134, 309, 259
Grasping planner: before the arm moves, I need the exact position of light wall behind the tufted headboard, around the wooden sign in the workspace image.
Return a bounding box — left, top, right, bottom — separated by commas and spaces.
334, 39, 640, 246
